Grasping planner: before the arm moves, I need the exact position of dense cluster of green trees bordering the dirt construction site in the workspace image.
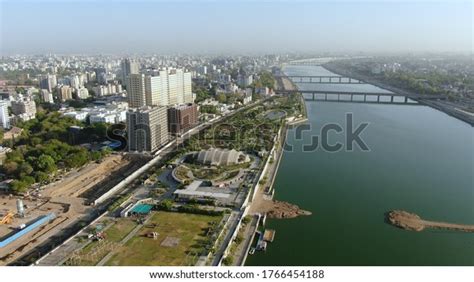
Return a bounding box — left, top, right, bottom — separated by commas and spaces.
0, 112, 111, 193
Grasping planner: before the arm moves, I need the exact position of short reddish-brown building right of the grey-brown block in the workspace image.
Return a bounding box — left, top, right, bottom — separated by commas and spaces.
168, 104, 198, 135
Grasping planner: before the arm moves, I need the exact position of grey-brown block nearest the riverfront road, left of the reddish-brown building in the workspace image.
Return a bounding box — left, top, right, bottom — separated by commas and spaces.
127, 107, 169, 152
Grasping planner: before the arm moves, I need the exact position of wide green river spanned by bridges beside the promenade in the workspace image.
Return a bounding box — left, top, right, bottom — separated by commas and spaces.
246, 66, 474, 266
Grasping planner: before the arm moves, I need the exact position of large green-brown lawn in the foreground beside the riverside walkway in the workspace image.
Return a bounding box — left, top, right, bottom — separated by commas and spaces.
107, 211, 222, 265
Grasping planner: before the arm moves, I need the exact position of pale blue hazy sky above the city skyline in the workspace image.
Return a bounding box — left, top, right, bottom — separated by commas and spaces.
0, 0, 474, 54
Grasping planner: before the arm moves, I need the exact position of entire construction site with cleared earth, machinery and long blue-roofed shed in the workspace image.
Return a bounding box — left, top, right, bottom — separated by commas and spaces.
0, 154, 149, 265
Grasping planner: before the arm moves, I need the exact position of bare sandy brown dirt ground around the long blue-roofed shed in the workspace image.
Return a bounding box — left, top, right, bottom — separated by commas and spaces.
0, 155, 130, 265
